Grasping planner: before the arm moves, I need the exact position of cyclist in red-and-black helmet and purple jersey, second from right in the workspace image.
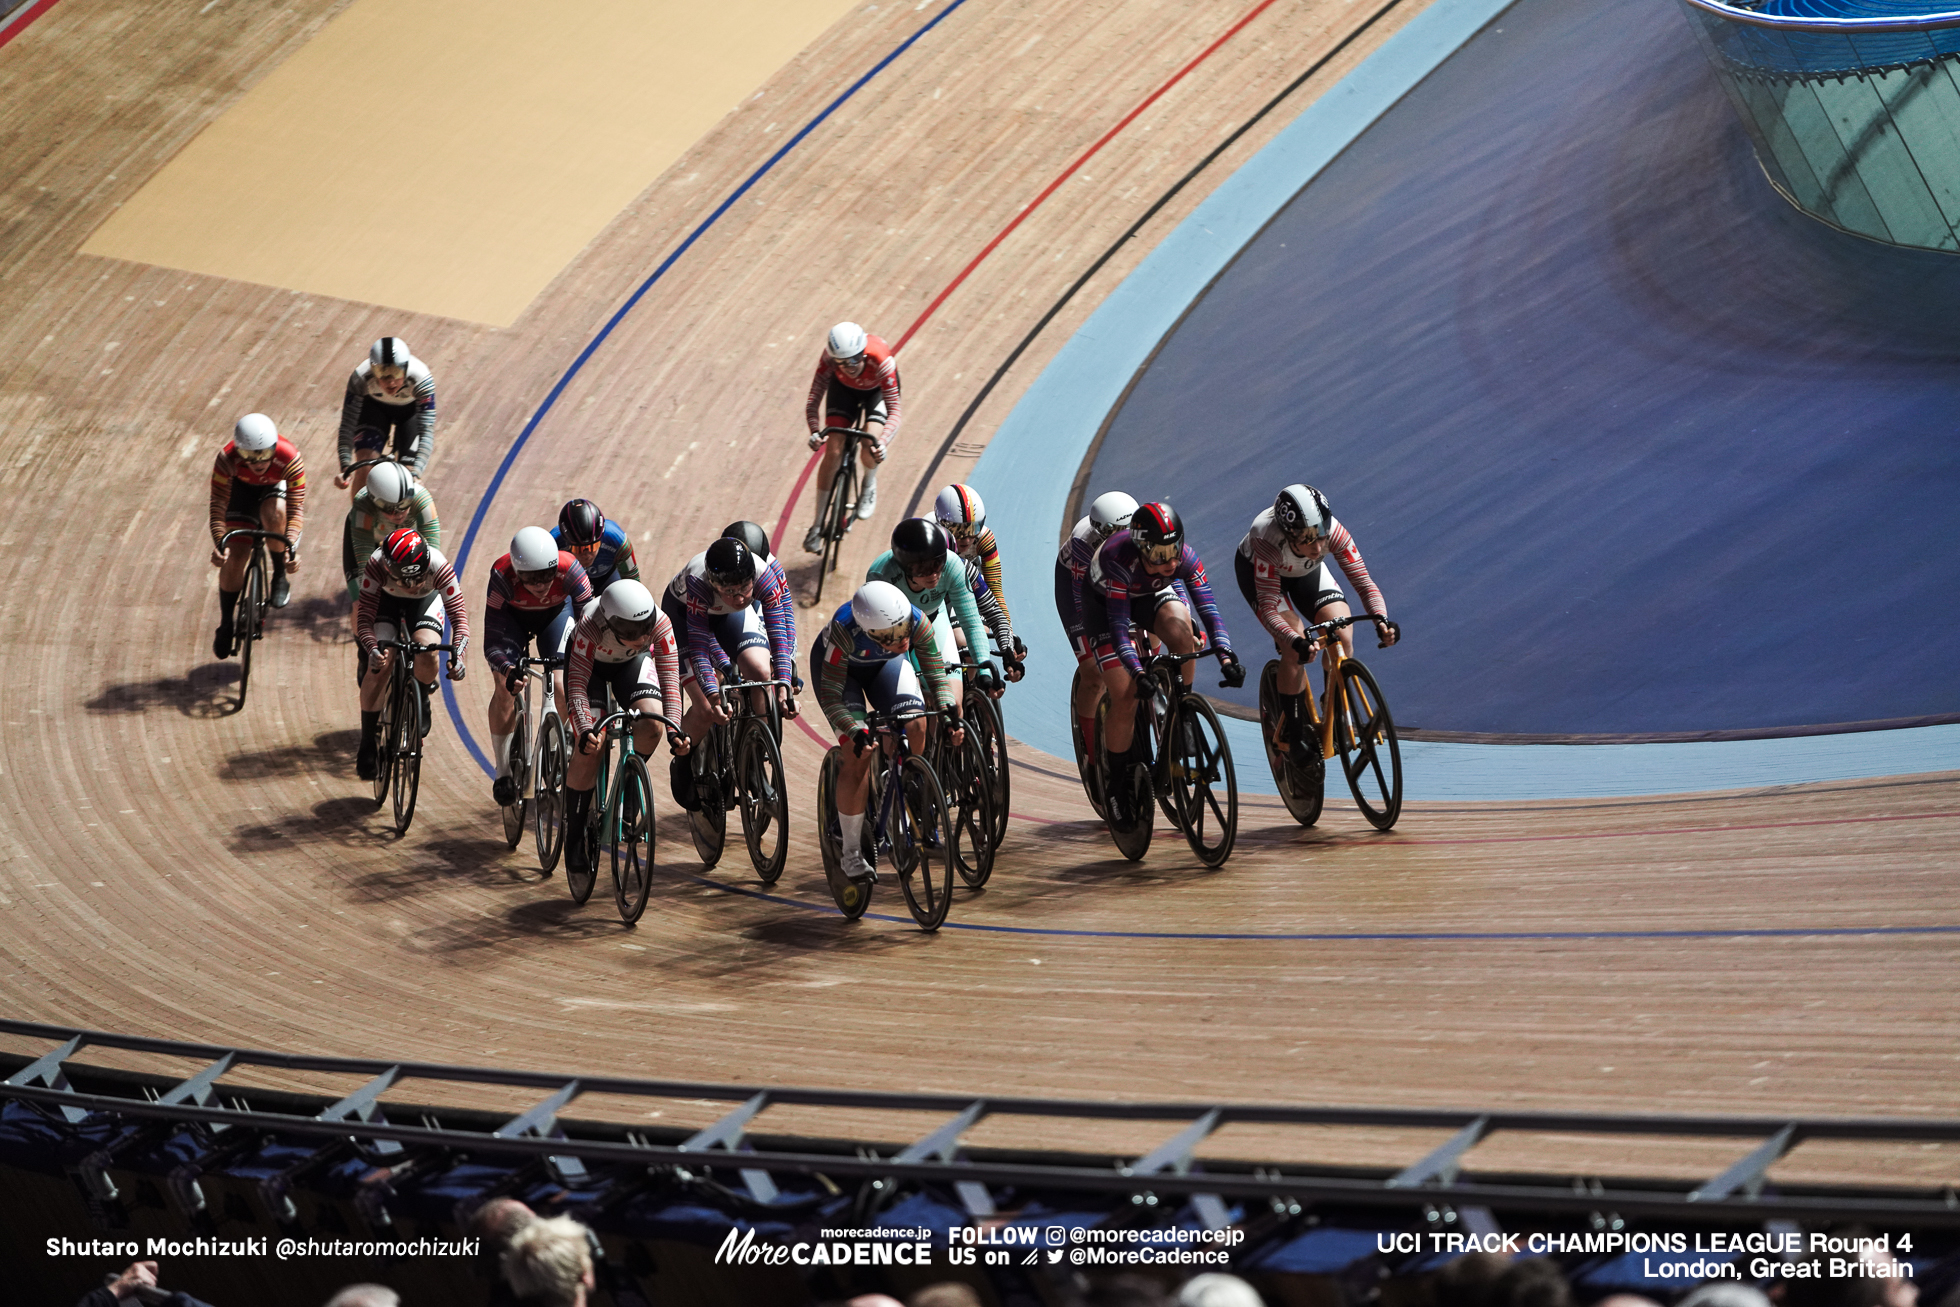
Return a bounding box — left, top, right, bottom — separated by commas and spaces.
1078, 504, 1245, 823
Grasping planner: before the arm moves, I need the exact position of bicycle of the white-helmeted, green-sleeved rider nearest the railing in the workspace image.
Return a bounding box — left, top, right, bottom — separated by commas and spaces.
817, 707, 953, 931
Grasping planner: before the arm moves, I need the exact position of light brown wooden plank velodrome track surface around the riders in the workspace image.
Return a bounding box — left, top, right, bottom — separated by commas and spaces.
0, 0, 1960, 1182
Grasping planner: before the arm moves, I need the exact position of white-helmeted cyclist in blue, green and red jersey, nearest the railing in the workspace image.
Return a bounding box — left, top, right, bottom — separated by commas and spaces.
809, 580, 966, 880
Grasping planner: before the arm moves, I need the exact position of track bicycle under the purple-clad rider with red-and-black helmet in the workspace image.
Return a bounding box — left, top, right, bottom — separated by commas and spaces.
1096, 645, 1239, 866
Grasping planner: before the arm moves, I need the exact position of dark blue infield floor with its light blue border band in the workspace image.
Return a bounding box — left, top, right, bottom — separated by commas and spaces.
974, 0, 1960, 799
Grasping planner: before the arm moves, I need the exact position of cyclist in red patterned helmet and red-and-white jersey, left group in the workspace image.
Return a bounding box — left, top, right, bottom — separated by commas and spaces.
355, 527, 470, 780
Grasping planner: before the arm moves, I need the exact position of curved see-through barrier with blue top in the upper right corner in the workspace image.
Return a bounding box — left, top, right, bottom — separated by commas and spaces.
1680, 0, 1960, 253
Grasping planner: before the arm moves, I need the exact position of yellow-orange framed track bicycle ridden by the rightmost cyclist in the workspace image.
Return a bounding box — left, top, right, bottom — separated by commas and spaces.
1258, 613, 1401, 831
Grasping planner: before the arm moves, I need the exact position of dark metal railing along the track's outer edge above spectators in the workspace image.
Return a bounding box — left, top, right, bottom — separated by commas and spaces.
0, 1021, 1960, 1231
